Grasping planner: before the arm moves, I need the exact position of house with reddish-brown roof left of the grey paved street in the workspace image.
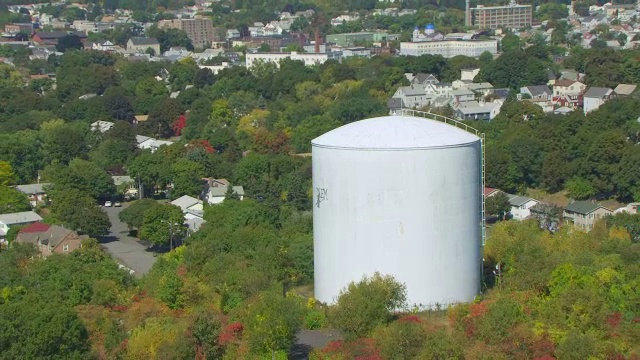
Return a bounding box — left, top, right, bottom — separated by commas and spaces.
16, 222, 89, 258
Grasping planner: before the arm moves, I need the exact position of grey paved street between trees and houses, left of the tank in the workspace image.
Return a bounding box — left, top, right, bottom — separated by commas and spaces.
101, 207, 156, 277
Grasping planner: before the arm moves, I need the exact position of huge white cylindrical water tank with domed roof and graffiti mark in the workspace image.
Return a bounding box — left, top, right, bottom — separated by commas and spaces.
311, 116, 482, 308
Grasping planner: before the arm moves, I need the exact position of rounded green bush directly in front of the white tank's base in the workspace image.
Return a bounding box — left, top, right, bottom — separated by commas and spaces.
329, 273, 407, 339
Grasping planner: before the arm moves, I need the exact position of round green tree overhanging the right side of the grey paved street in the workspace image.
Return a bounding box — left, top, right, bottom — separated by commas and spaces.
138, 205, 184, 248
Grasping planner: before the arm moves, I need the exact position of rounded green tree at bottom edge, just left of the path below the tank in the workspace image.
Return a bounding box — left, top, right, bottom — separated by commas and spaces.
244, 292, 303, 358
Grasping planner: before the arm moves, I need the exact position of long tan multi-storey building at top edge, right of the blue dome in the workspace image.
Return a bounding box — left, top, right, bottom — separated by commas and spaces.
468, 0, 533, 29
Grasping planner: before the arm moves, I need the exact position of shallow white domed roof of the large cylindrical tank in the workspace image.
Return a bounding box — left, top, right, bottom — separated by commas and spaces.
311, 115, 480, 150
